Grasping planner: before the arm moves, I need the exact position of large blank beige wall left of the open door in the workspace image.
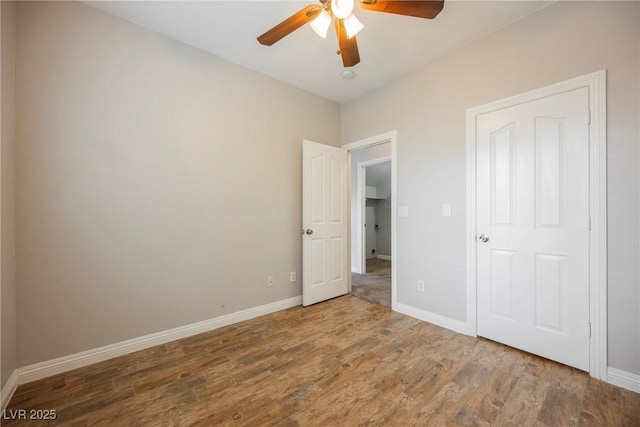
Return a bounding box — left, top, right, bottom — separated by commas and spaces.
16, 2, 340, 366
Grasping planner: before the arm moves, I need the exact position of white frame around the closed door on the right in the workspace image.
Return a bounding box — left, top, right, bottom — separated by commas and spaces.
467, 70, 607, 381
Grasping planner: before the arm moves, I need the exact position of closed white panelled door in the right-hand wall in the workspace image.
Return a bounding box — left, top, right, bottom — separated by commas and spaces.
476, 87, 590, 371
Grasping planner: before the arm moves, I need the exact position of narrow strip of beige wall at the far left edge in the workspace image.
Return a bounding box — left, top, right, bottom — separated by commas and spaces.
0, 1, 17, 387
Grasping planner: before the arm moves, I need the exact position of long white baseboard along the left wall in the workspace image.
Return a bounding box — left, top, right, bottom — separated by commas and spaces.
16, 296, 302, 386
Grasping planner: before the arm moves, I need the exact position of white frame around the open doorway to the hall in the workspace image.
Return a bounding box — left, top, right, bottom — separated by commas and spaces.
342, 130, 398, 311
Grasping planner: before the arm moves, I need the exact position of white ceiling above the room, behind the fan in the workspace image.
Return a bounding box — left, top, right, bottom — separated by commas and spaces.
86, 0, 553, 103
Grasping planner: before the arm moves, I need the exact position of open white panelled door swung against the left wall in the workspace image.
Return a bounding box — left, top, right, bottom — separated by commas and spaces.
302, 141, 349, 306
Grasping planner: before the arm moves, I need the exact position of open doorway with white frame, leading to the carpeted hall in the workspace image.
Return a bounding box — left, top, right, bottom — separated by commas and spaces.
343, 132, 396, 309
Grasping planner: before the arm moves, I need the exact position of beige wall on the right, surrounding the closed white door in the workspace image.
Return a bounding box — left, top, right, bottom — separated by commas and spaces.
341, 2, 640, 374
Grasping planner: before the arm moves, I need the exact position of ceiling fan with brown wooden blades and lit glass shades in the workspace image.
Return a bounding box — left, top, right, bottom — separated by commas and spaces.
258, 0, 444, 67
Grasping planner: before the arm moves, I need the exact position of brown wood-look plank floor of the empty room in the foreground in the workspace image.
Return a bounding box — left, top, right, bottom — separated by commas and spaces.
3, 295, 640, 427
